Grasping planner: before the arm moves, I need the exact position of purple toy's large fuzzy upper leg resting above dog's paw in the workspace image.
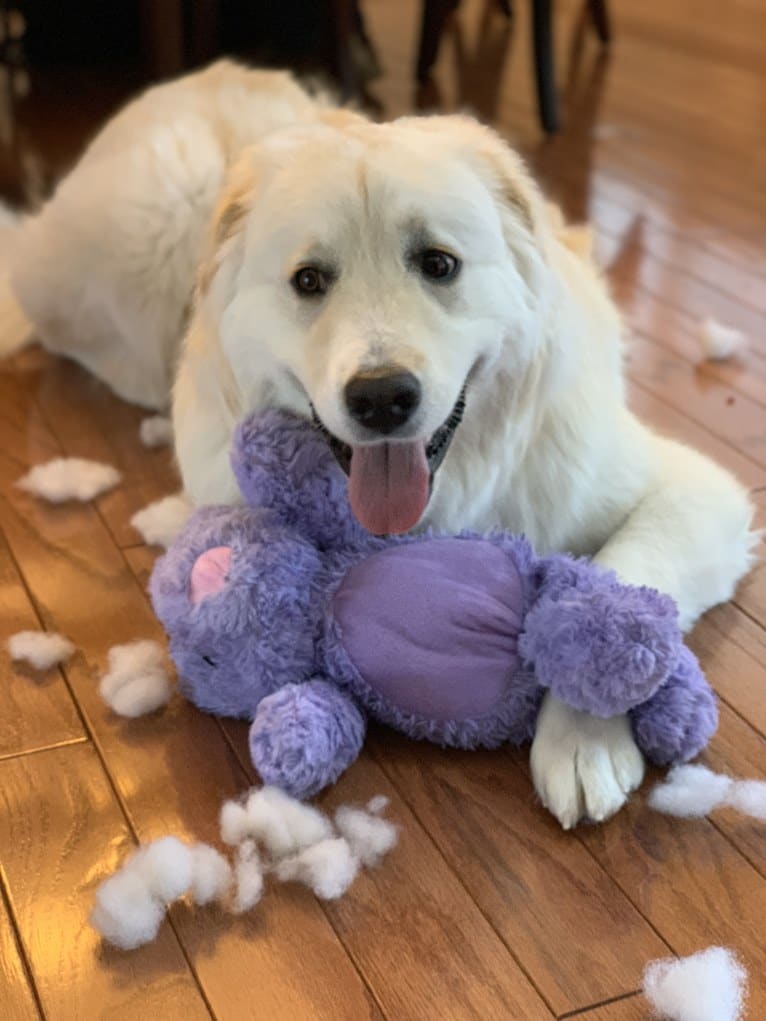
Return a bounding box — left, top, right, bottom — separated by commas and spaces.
519, 555, 682, 717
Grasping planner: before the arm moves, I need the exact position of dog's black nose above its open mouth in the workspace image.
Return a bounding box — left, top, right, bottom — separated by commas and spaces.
343, 366, 421, 436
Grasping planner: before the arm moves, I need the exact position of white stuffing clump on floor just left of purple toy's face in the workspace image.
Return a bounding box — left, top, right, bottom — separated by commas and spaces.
99, 638, 173, 719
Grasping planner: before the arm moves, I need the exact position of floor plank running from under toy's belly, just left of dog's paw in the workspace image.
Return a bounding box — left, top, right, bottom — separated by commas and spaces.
373, 731, 667, 1015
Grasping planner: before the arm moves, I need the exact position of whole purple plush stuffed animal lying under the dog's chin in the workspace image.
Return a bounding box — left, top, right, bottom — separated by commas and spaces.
150, 411, 717, 797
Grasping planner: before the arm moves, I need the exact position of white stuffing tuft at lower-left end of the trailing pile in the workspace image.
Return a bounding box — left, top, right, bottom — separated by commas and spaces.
91, 867, 164, 951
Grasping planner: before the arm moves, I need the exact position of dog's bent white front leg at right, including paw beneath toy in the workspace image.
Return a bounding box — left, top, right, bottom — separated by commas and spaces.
531, 436, 756, 829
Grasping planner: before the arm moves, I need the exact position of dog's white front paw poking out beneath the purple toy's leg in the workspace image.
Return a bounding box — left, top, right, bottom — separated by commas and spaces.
530, 694, 643, 829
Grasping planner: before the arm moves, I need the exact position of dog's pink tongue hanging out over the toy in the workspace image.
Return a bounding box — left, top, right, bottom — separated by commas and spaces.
348, 442, 430, 535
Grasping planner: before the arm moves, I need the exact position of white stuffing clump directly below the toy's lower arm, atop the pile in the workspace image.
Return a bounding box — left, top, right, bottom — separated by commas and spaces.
221, 786, 333, 860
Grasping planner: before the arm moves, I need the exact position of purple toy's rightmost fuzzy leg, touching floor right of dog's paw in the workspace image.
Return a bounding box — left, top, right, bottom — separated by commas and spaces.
629, 647, 718, 766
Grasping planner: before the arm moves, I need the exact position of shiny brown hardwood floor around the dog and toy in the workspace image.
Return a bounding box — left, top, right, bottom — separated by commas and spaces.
0, 0, 766, 1021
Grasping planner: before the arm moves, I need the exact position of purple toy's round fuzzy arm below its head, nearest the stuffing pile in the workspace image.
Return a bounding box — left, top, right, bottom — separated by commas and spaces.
250, 678, 367, 798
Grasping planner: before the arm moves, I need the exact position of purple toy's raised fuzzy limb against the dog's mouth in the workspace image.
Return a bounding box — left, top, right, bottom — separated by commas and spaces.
232, 408, 365, 547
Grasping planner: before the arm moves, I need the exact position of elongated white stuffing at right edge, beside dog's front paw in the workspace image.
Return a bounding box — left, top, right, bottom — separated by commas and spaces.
649, 766, 766, 820
